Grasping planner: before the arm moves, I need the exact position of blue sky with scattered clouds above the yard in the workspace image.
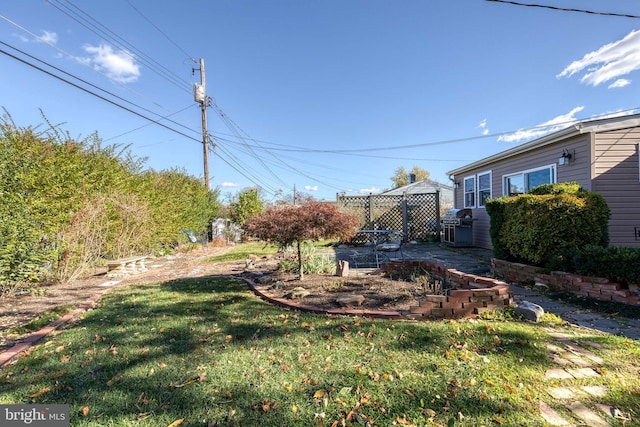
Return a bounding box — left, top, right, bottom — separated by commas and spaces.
0, 0, 640, 200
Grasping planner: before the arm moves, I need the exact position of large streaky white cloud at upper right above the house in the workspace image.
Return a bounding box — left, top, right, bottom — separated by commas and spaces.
556, 30, 640, 87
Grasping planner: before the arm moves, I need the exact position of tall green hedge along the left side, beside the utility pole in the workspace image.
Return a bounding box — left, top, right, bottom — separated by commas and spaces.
0, 114, 220, 293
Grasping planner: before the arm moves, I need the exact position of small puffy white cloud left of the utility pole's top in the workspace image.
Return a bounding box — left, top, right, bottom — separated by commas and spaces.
84, 44, 140, 83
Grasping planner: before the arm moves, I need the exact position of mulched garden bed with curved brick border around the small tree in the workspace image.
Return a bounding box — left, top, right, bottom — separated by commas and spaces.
245, 261, 513, 319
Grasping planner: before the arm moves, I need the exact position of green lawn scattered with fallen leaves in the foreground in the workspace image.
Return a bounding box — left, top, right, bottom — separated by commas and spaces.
0, 272, 640, 427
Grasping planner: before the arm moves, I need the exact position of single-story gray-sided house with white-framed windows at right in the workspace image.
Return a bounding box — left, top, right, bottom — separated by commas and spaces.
449, 114, 640, 248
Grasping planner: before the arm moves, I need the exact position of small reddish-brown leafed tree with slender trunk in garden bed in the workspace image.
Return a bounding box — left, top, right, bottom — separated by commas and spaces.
244, 201, 358, 280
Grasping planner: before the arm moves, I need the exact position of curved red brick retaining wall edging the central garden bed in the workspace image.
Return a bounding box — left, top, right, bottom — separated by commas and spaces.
381, 261, 513, 319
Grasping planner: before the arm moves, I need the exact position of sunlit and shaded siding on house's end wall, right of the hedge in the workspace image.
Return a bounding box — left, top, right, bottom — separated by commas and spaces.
592, 128, 640, 247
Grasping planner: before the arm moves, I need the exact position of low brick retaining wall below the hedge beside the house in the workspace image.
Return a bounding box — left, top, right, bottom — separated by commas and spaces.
491, 258, 640, 306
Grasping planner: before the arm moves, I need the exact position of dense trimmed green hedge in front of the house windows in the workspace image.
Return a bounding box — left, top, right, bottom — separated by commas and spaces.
486, 183, 609, 266
